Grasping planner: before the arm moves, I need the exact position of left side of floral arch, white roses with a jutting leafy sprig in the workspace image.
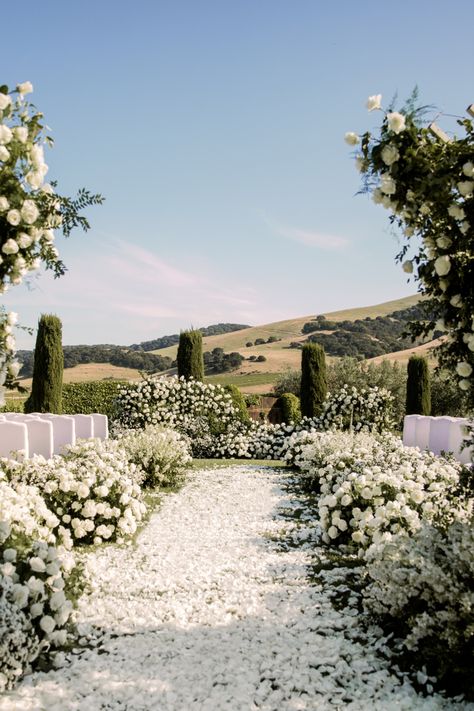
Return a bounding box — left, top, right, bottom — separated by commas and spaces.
0, 81, 103, 404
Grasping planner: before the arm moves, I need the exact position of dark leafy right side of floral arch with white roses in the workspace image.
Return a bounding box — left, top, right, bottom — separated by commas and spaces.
345, 93, 474, 400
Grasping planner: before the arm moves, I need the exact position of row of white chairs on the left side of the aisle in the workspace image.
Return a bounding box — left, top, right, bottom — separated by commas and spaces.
0, 412, 109, 459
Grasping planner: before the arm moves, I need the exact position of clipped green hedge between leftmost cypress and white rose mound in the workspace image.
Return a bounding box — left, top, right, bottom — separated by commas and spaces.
63, 380, 127, 420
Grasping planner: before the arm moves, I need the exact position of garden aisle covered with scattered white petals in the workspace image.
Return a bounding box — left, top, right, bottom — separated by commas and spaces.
0, 466, 474, 711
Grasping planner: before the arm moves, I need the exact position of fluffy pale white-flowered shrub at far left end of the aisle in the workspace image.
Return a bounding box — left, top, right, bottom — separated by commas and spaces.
119, 425, 191, 488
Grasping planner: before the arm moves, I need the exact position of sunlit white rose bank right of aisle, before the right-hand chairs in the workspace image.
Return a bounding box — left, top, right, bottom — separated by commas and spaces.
290, 432, 469, 556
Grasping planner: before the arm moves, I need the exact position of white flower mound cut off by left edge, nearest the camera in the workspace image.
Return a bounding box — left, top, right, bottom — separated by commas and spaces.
0, 472, 78, 692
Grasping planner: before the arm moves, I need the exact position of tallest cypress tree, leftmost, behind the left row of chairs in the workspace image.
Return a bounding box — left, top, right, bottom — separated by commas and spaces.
25, 314, 64, 414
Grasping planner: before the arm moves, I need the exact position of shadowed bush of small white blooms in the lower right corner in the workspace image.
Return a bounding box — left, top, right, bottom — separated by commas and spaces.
364, 521, 474, 663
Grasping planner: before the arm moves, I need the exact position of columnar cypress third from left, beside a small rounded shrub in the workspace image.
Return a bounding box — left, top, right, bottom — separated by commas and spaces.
300, 343, 328, 417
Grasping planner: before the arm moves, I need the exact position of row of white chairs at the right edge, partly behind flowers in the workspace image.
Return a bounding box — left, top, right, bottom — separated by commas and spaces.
403, 415, 474, 464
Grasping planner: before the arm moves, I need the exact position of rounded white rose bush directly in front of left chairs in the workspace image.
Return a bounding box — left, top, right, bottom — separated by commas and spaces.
4, 439, 145, 545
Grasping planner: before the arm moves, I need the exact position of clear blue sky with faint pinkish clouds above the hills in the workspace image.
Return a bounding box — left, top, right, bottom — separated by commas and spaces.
0, 0, 474, 347
